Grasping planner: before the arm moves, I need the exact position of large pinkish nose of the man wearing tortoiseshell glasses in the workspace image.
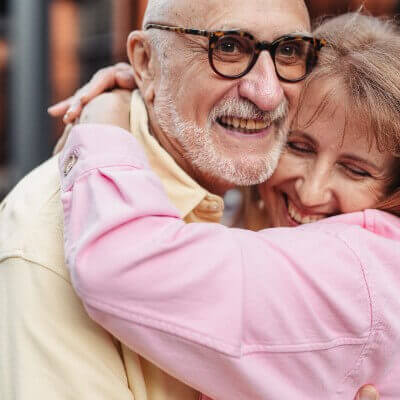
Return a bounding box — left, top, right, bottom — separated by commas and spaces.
239, 51, 284, 111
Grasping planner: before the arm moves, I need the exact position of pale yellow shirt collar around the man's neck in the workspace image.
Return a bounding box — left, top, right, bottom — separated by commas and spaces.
130, 90, 223, 220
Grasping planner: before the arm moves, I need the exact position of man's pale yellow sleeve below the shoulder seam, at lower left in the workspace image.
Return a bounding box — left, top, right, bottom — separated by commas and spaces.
0, 257, 133, 400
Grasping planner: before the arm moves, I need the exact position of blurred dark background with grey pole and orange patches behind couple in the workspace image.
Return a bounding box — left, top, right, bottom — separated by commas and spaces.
0, 0, 400, 200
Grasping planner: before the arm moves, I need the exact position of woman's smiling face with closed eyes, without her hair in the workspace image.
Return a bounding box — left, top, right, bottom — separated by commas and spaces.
259, 83, 393, 227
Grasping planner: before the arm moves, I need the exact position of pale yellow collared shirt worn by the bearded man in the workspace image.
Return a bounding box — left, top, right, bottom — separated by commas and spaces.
0, 92, 223, 400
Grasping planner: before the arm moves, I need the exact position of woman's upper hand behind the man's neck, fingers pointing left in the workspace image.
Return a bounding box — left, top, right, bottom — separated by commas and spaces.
48, 63, 136, 124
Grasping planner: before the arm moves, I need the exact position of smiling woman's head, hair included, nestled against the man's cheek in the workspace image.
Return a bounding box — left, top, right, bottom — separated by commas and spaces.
244, 16, 400, 228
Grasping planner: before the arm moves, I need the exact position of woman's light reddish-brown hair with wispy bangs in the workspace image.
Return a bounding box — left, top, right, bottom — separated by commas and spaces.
240, 12, 400, 229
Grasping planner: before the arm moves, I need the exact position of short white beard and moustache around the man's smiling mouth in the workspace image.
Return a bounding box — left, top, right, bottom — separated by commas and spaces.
154, 85, 288, 186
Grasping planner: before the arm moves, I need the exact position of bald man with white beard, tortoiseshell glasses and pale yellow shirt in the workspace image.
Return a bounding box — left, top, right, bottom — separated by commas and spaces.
0, 0, 376, 400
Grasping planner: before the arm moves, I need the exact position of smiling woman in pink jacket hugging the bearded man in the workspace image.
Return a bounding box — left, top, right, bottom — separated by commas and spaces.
60, 15, 400, 399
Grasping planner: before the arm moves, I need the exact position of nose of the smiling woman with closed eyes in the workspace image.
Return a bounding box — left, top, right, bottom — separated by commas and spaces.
295, 169, 333, 208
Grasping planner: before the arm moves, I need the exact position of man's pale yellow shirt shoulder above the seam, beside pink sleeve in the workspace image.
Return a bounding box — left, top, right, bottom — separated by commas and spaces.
0, 156, 66, 276
